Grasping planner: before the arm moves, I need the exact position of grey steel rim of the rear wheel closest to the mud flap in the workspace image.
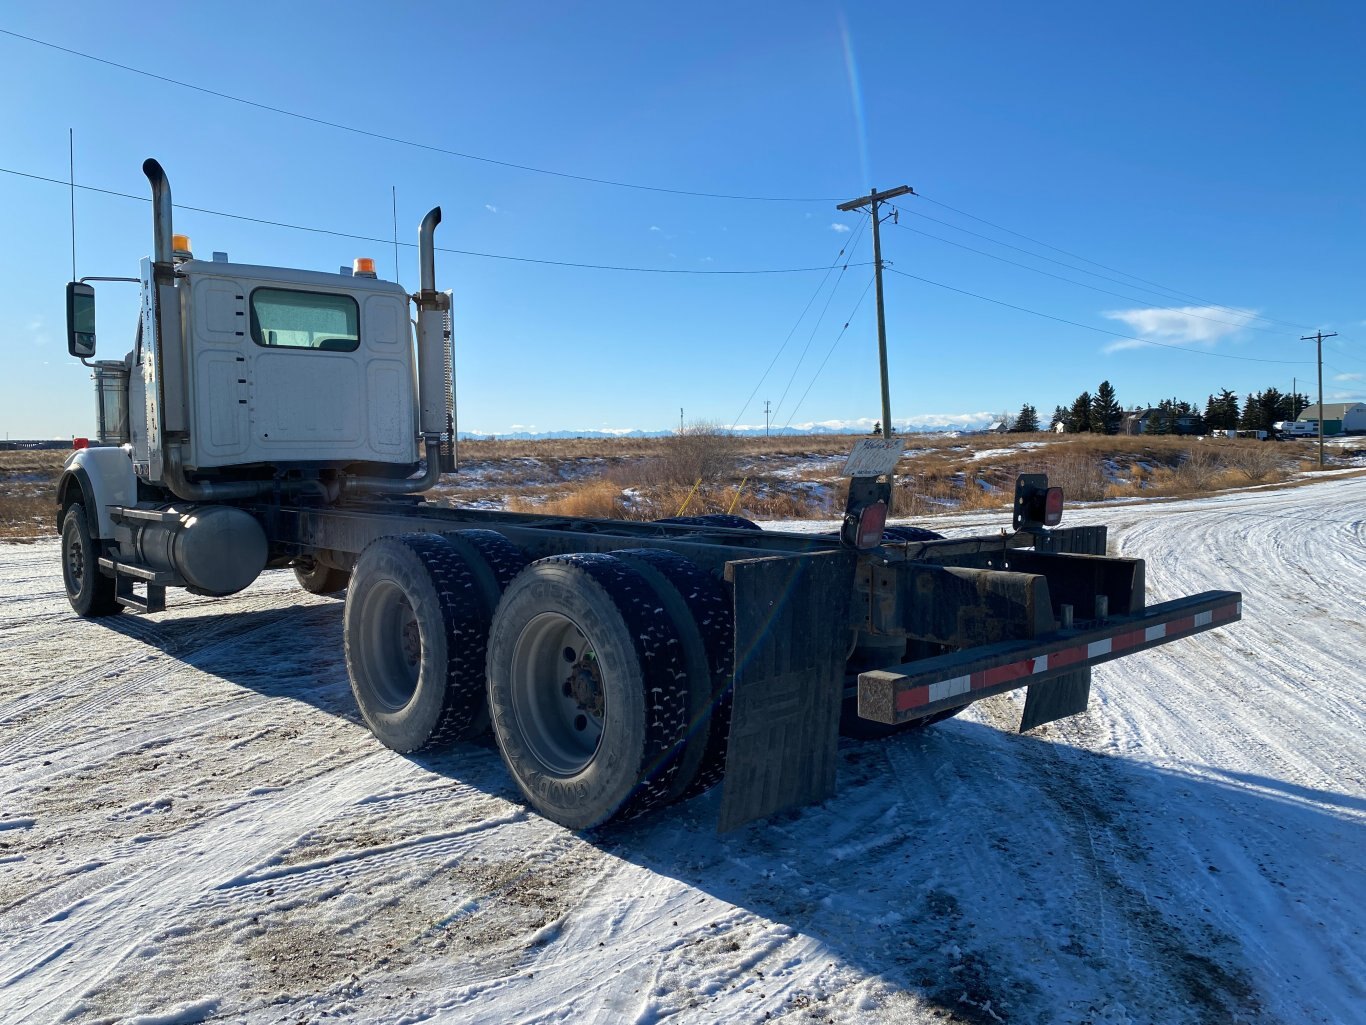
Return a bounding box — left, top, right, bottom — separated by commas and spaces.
511, 612, 607, 776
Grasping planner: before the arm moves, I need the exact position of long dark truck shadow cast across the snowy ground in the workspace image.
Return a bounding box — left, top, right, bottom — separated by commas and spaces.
99, 599, 1366, 1025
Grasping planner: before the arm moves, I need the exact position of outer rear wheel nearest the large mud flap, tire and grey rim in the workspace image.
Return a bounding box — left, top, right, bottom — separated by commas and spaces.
488, 555, 690, 830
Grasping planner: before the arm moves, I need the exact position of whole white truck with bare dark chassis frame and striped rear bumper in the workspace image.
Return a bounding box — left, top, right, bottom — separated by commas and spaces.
57, 160, 1242, 830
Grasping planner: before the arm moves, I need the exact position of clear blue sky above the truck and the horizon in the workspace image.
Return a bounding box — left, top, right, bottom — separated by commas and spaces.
0, 1, 1366, 436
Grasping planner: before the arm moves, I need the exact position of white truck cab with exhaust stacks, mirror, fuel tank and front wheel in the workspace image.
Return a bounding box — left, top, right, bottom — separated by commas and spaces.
57, 160, 455, 612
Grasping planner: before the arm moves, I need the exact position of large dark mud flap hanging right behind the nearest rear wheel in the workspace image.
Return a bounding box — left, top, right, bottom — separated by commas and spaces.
717, 551, 855, 832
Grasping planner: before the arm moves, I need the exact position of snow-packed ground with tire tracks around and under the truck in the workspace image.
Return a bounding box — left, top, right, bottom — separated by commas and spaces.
0, 478, 1366, 1025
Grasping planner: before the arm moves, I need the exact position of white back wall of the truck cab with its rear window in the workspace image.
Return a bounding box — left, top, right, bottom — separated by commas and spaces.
168, 260, 418, 472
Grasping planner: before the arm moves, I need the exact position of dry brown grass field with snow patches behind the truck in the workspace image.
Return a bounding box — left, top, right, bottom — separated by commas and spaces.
0, 429, 1366, 540
